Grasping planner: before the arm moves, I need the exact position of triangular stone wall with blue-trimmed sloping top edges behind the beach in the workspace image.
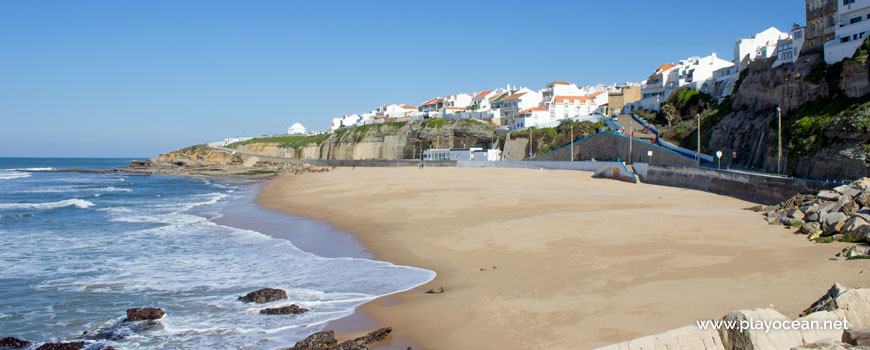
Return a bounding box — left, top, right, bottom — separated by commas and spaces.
534, 132, 695, 165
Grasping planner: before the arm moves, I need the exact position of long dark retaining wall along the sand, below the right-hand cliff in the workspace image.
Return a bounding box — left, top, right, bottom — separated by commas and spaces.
633, 163, 843, 204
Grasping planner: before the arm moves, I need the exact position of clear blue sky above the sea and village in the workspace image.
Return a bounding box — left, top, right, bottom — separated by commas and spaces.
0, 0, 805, 158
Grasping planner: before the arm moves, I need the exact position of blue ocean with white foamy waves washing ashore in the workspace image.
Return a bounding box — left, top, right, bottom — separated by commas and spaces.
0, 158, 435, 349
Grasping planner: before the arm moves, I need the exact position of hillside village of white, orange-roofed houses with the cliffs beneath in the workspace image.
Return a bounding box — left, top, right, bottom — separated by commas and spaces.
213, 0, 870, 179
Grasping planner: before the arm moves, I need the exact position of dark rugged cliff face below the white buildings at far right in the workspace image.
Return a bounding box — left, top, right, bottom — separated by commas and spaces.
705, 54, 870, 179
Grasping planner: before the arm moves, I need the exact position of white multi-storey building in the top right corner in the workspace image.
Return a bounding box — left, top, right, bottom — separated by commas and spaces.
825, 0, 870, 64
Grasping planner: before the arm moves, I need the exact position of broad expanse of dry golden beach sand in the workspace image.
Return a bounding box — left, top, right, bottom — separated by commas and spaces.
259, 168, 870, 350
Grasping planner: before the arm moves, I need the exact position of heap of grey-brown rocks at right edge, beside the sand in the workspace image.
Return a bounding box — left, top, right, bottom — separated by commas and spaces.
749, 178, 870, 260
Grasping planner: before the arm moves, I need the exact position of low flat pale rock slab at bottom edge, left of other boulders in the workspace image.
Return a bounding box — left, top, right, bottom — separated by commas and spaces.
596, 325, 725, 350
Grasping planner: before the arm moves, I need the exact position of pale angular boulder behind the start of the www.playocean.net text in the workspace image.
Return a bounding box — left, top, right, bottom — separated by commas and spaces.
719, 308, 804, 350
